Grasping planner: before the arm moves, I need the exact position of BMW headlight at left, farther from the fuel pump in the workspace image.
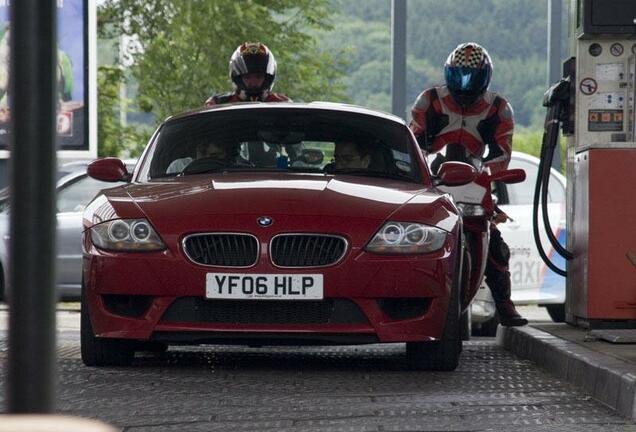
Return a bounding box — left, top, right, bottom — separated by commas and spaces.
90, 219, 166, 252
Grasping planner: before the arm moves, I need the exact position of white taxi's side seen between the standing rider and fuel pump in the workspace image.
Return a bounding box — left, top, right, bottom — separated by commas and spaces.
498, 156, 565, 304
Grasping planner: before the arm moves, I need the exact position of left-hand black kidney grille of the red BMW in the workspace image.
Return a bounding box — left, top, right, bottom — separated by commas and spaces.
184, 234, 258, 267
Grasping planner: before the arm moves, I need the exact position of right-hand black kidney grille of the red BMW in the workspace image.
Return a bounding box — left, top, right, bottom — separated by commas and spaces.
271, 234, 347, 267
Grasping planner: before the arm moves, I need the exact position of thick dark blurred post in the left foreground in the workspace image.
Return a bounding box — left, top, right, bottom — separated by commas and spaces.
7, 0, 57, 413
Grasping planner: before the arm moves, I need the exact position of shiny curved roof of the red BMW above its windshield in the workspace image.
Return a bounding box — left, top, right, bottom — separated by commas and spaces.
165, 101, 406, 126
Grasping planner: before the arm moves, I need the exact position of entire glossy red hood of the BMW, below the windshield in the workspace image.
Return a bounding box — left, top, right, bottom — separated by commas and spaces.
90, 173, 452, 240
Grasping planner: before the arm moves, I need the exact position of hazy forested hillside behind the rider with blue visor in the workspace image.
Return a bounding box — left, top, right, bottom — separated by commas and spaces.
318, 0, 567, 128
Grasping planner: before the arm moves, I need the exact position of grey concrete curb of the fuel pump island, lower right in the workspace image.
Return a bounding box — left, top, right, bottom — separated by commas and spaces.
497, 326, 636, 421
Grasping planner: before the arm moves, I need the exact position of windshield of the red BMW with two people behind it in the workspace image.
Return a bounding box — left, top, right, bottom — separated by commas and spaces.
142, 108, 420, 181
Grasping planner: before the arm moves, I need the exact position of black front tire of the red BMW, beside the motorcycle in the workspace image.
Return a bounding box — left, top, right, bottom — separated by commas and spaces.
406, 248, 462, 371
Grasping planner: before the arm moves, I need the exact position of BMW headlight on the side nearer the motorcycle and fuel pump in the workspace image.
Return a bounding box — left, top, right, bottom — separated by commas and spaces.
365, 222, 447, 254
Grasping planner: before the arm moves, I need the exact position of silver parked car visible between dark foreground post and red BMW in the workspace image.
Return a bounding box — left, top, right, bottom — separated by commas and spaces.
57, 173, 122, 295
